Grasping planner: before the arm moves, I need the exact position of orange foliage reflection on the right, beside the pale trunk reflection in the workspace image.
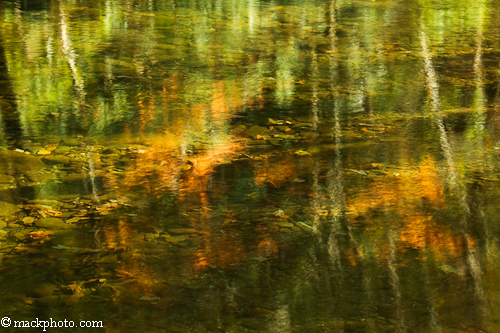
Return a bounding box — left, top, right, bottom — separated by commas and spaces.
347, 156, 465, 256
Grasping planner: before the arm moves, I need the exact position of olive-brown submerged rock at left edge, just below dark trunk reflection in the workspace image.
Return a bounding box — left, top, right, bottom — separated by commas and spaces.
0, 150, 45, 175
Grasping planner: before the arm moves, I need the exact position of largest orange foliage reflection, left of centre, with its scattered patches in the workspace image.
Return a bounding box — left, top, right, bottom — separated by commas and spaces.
94, 77, 266, 286
